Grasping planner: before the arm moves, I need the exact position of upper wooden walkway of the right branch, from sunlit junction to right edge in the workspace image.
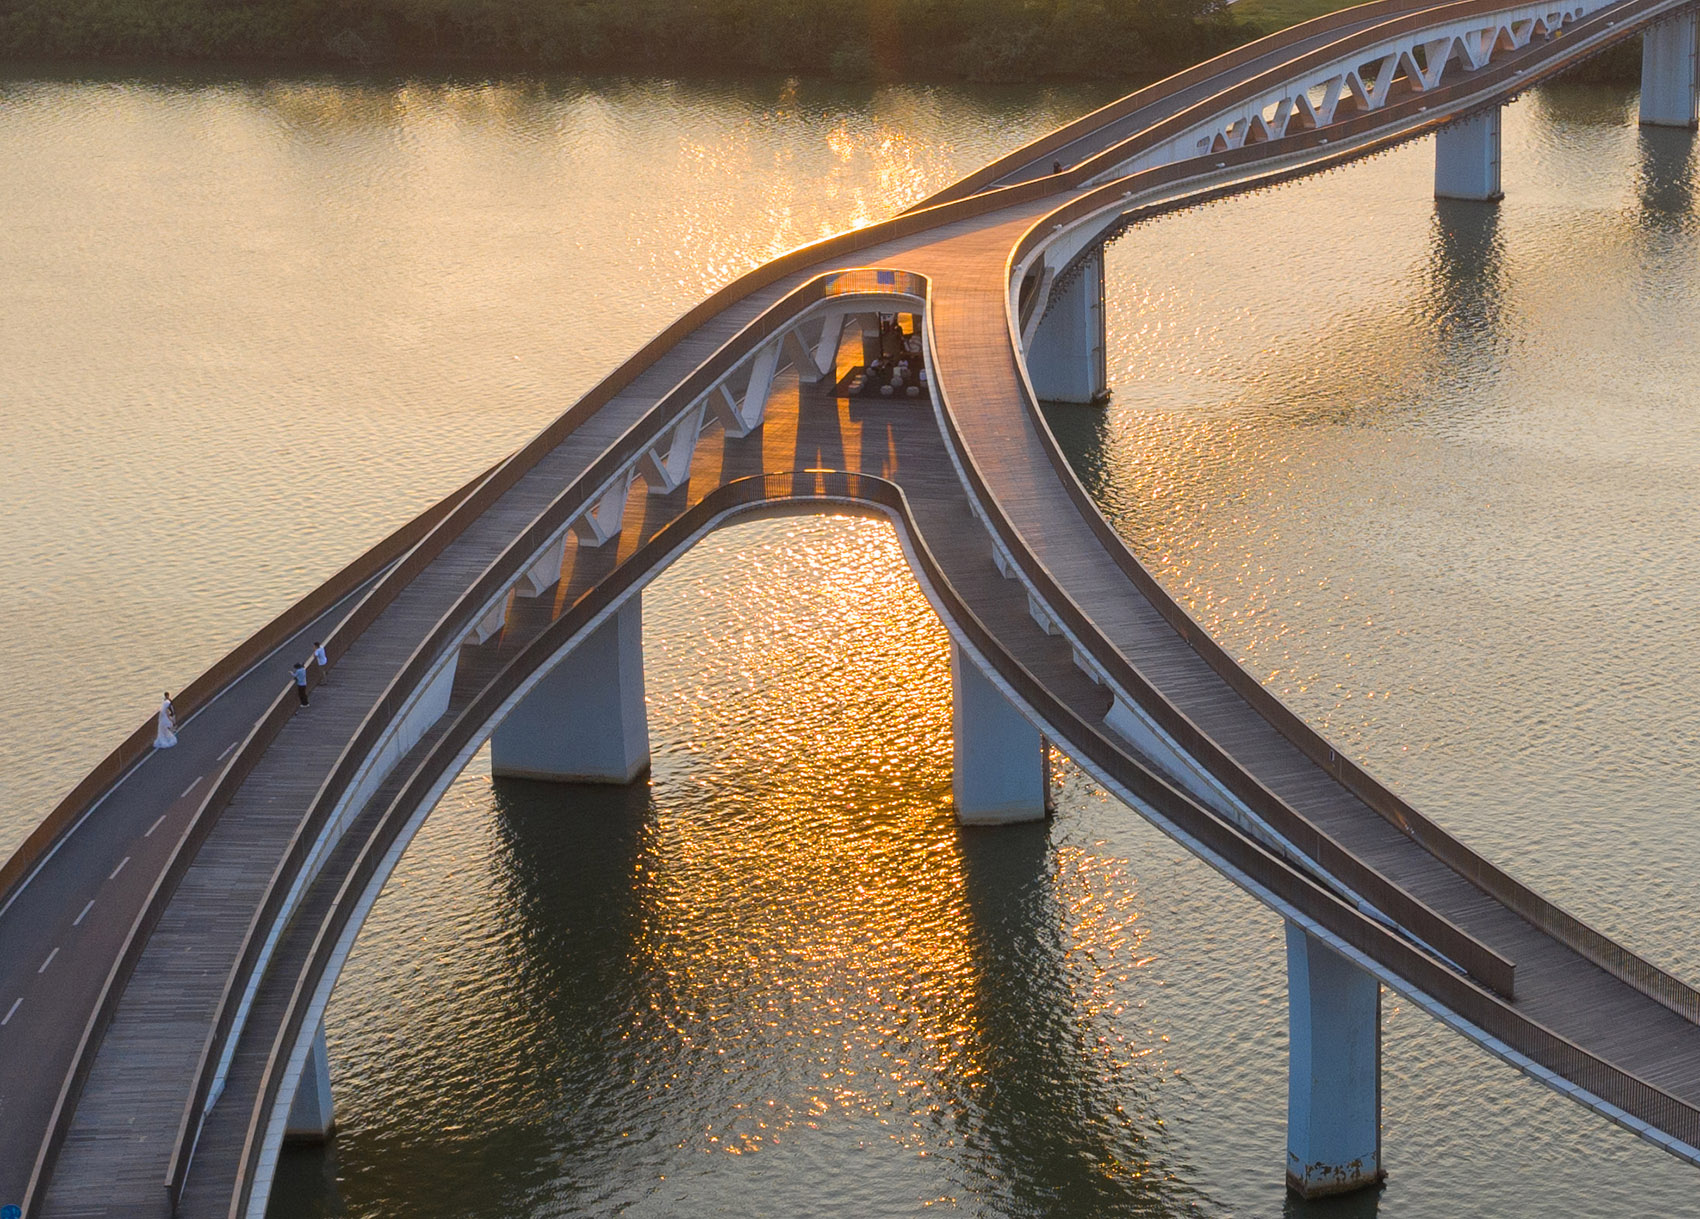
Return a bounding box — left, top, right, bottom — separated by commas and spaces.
910, 224, 1700, 1102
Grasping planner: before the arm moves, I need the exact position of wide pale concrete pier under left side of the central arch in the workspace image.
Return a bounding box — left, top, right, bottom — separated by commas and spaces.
490, 595, 649, 784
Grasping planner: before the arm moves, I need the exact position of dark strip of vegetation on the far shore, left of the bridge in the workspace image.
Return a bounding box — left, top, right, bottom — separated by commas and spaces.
0, 0, 1244, 82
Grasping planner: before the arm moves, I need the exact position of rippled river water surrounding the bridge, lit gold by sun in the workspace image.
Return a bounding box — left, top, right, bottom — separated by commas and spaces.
0, 68, 1700, 1219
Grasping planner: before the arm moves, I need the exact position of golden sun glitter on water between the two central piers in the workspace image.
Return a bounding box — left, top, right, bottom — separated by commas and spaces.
634, 520, 976, 1149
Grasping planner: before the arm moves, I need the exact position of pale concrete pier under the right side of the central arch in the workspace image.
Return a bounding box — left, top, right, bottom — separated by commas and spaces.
950, 644, 1049, 825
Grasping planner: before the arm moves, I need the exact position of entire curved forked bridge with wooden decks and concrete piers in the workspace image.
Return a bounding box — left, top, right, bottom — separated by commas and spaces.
0, 0, 1700, 1217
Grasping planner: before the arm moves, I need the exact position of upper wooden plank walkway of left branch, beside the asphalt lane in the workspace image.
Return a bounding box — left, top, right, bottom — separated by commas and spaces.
43, 270, 802, 1216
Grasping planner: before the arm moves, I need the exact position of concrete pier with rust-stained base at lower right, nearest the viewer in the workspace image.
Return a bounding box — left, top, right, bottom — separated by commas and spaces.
1287, 923, 1386, 1199
